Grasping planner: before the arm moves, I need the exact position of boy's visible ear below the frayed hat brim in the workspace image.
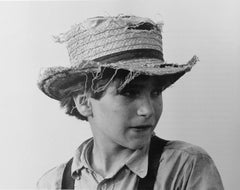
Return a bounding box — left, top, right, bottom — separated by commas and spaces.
73, 95, 92, 117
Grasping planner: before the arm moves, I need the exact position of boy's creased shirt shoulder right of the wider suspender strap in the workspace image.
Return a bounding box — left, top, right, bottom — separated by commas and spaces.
157, 141, 223, 189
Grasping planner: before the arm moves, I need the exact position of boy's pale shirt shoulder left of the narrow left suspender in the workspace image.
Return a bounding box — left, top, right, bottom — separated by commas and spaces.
37, 163, 66, 189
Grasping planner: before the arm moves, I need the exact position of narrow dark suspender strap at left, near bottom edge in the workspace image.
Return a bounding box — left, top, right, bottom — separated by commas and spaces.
61, 158, 74, 189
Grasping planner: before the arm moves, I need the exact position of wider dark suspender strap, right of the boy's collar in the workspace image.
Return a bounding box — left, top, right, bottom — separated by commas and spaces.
138, 136, 168, 190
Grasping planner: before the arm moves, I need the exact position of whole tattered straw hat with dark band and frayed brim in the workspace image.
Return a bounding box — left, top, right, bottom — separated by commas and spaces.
38, 15, 198, 100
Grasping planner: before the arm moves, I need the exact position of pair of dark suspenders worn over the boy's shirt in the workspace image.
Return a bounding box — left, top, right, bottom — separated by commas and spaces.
62, 136, 168, 190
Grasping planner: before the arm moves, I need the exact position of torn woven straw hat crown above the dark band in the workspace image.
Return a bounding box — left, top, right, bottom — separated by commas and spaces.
54, 15, 162, 66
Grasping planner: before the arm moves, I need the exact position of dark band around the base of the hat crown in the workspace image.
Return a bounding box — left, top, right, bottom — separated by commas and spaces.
94, 49, 164, 63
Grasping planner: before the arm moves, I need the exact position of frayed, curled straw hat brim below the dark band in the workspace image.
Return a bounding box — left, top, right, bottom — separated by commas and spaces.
38, 56, 198, 100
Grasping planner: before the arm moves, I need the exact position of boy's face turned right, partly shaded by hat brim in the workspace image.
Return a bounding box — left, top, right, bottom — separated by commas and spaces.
88, 77, 162, 149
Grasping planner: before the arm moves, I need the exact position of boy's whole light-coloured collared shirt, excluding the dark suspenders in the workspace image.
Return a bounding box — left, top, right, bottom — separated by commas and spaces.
37, 139, 224, 190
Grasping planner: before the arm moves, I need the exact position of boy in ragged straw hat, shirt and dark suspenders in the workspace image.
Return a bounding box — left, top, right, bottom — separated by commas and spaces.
38, 15, 223, 190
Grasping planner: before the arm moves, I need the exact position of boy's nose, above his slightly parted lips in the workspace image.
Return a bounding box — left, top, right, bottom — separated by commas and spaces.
137, 97, 154, 118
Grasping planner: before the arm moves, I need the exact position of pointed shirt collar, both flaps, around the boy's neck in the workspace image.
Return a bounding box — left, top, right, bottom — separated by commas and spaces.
71, 138, 149, 179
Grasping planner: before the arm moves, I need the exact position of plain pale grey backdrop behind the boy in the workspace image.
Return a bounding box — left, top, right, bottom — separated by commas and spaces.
0, 0, 240, 189
